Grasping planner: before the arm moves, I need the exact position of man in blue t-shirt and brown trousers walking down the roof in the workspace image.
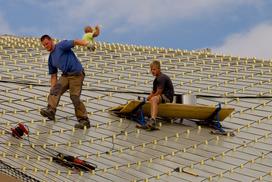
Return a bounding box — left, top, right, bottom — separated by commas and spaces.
40, 35, 90, 129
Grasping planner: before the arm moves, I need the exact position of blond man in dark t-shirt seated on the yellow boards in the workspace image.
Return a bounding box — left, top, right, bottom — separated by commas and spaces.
147, 61, 174, 128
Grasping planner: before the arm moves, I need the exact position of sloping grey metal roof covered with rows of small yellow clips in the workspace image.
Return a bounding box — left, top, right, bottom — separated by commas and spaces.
0, 35, 272, 182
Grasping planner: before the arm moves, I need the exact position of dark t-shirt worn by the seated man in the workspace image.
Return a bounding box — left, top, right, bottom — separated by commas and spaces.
153, 73, 174, 102
